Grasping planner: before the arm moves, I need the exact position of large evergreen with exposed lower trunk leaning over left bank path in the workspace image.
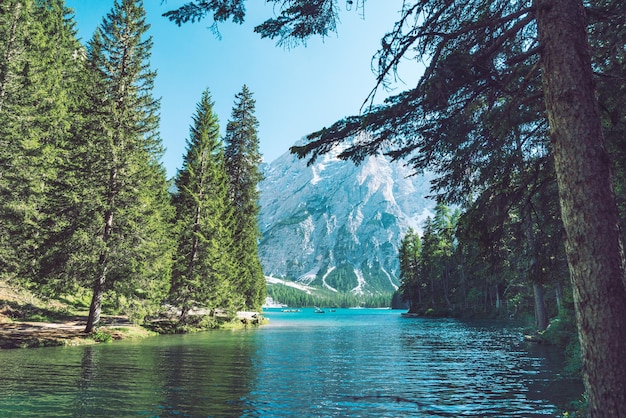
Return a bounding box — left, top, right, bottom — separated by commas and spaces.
76, 0, 172, 332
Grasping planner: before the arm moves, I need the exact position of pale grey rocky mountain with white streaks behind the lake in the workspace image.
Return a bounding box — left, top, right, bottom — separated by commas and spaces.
259, 140, 434, 295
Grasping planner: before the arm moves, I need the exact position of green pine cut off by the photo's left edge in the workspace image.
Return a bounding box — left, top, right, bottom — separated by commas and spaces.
0, 1, 39, 277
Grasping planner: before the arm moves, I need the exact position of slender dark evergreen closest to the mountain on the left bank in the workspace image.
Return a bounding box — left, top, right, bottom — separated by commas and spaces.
225, 85, 266, 309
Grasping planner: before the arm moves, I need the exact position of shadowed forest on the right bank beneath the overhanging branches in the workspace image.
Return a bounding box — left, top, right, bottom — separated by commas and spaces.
399, 203, 575, 326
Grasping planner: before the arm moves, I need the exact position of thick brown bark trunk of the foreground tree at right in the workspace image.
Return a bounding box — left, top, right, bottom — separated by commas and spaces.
535, 0, 626, 417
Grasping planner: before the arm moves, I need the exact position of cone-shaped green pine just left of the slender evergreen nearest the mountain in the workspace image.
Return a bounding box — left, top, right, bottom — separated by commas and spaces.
170, 90, 237, 323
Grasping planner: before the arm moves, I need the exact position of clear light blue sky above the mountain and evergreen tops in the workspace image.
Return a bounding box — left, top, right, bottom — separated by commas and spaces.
66, 0, 420, 176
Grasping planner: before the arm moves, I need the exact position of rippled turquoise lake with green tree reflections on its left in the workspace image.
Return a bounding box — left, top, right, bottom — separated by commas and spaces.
0, 309, 582, 417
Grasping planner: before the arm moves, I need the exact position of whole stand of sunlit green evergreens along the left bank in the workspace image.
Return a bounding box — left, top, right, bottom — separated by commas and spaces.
0, 0, 265, 331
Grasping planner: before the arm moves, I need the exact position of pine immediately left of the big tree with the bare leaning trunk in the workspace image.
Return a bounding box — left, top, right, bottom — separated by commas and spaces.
34, 0, 91, 293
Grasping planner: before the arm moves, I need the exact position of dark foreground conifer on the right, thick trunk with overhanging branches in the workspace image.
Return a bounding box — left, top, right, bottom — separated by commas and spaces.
168, 0, 626, 416
